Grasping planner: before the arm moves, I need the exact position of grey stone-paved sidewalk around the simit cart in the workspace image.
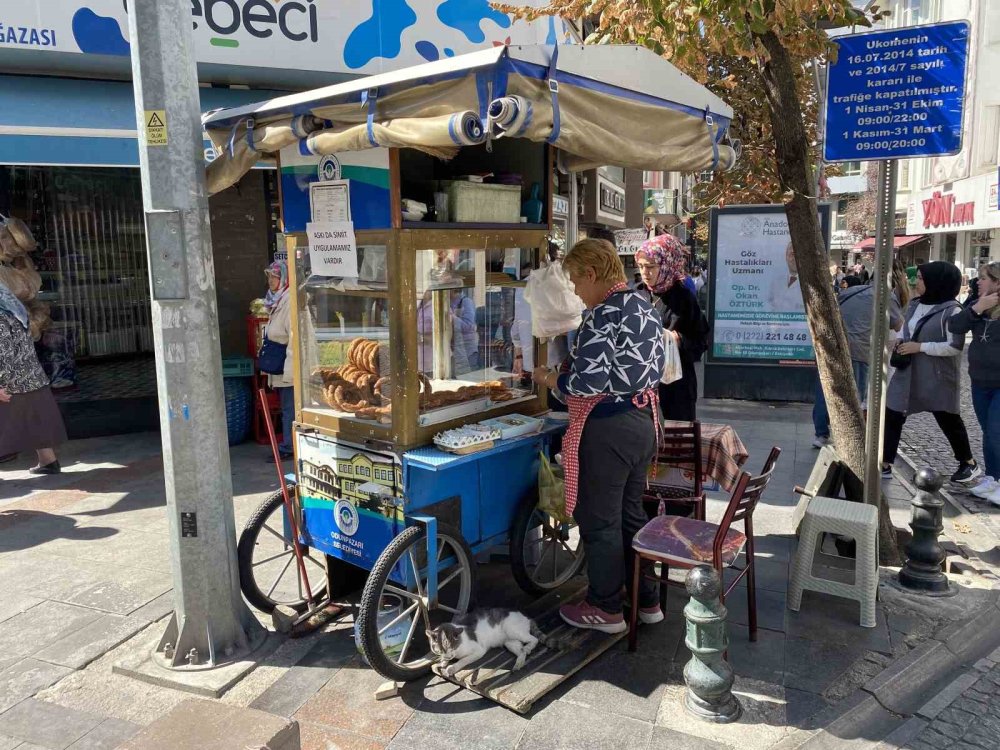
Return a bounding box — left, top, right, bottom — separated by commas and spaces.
0, 402, 992, 750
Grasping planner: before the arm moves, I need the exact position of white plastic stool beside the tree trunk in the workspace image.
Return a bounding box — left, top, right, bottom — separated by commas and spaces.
788, 497, 878, 628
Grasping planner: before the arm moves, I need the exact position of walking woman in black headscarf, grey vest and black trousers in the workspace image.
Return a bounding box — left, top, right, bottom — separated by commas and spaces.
882, 261, 982, 484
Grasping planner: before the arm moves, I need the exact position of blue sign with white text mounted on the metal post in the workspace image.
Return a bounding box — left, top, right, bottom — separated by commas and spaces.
823, 21, 969, 162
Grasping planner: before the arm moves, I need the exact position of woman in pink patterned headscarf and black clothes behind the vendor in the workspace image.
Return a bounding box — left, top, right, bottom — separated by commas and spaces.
635, 234, 705, 422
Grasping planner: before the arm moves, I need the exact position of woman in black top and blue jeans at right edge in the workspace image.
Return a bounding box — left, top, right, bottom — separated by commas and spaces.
948, 263, 1000, 505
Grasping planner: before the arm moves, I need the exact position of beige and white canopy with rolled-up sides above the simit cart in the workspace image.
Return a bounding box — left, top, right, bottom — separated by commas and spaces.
204, 45, 736, 193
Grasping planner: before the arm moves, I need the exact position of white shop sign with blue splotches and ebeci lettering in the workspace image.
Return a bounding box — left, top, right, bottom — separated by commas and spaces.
0, 0, 570, 73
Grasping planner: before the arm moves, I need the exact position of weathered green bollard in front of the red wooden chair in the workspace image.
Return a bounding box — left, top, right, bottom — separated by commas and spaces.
684, 565, 743, 724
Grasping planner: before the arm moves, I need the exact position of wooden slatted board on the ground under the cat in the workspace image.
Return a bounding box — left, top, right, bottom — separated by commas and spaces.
433, 584, 626, 714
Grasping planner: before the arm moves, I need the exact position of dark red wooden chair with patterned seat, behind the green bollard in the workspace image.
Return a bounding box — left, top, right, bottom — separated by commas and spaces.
628, 446, 781, 651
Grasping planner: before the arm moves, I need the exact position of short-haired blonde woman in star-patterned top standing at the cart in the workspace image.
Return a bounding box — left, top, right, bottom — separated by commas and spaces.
532, 239, 664, 633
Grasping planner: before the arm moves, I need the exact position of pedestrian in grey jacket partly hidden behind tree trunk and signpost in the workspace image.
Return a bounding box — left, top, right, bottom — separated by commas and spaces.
813, 284, 903, 448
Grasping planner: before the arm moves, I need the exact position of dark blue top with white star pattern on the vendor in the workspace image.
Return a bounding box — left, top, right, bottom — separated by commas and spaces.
558, 291, 664, 405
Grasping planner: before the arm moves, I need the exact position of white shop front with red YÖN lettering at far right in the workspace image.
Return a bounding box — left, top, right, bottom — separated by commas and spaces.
906, 170, 1000, 270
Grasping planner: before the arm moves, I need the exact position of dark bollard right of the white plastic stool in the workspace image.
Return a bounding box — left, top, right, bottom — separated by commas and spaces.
899, 469, 948, 594
